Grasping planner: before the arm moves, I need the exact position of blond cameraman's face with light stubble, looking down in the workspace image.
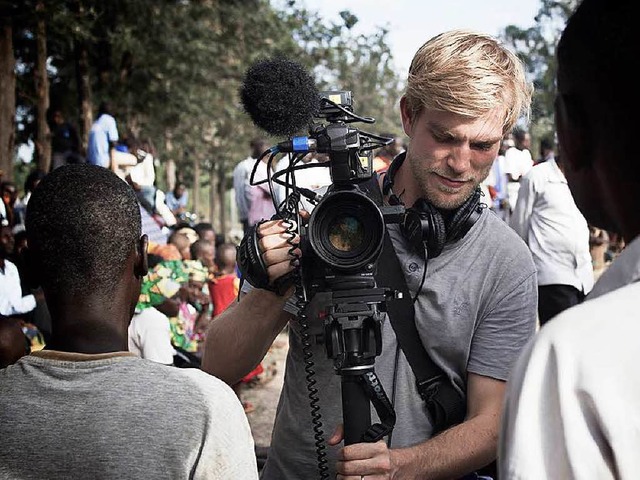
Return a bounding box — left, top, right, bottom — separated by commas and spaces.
401, 99, 504, 209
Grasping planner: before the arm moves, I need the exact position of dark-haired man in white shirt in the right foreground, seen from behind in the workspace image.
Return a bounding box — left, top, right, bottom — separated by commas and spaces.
498, 0, 640, 480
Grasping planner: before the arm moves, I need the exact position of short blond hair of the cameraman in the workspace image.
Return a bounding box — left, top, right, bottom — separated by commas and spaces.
405, 30, 533, 133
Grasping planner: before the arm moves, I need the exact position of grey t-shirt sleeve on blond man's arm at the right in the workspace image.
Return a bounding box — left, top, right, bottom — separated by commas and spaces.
467, 262, 538, 380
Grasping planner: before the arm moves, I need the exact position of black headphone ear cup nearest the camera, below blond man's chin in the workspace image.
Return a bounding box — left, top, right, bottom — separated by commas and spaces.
402, 199, 447, 259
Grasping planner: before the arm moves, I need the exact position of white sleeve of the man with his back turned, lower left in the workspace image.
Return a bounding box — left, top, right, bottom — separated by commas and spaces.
186, 369, 258, 480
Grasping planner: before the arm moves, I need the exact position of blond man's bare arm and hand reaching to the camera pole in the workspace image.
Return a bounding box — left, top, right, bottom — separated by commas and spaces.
336, 373, 505, 480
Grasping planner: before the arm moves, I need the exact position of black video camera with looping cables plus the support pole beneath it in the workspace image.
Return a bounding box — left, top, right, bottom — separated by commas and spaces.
264, 91, 404, 444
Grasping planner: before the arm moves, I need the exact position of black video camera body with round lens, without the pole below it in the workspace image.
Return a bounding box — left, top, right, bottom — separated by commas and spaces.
292, 91, 402, 304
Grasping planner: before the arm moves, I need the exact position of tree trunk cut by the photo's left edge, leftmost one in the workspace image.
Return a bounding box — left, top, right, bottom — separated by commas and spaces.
0, 23, 16, 180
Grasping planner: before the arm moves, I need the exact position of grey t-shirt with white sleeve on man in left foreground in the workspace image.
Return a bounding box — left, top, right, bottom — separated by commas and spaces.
0, 351, 258, 480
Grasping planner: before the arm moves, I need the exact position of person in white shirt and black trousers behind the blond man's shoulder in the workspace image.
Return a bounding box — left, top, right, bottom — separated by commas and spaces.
510, 147, 593, 325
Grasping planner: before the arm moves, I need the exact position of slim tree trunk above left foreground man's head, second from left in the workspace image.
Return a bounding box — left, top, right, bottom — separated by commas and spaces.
34, 0, 51, 172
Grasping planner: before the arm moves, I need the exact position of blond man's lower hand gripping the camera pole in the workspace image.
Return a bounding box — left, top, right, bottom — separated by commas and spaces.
327, 425, 395, 480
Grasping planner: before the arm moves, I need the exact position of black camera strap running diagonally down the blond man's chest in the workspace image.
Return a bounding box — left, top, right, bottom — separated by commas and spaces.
361, 175, 466, 435
